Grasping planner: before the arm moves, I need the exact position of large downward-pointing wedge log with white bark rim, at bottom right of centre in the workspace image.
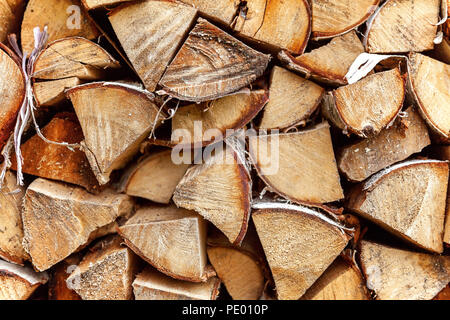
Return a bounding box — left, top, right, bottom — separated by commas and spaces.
252, 203, 351, 300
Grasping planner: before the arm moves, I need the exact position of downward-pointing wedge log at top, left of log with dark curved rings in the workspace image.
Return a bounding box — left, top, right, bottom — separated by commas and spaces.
109, 0, 197, 91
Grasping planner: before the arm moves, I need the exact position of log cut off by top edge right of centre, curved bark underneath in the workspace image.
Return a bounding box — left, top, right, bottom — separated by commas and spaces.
312, 0, 380, 40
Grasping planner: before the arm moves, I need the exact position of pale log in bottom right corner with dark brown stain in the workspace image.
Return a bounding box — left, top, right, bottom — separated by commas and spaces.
360, 241, 450, 300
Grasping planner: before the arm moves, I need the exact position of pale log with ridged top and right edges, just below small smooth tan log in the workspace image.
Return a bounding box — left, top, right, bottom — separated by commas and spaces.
119, 206, 214, 282
